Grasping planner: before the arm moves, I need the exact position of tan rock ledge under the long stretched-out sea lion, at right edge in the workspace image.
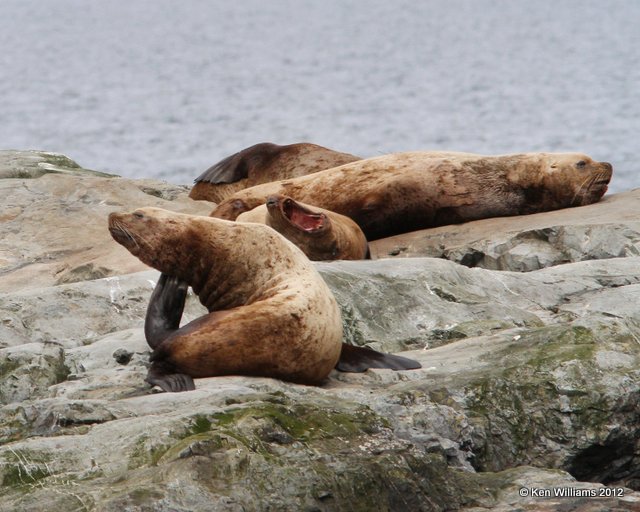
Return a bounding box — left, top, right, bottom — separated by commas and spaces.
370, 189, 640, 272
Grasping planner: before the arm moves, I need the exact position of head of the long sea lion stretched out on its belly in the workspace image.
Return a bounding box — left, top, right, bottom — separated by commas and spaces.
543, 153, 613, 207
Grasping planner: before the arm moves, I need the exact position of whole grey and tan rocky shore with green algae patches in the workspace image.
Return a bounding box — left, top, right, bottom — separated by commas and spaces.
0, 151, 640, 512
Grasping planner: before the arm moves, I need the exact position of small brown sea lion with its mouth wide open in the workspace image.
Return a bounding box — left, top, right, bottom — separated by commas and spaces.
236, 195, 369, 261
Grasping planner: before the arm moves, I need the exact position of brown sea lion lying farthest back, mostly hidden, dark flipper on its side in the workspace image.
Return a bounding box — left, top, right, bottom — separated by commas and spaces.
189, 142, 360, 203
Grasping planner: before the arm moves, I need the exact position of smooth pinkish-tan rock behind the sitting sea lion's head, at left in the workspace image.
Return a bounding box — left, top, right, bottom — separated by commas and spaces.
0, 151, 212, 293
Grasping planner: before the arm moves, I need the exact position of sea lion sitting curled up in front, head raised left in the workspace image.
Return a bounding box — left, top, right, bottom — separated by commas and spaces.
109, 208, 420, 391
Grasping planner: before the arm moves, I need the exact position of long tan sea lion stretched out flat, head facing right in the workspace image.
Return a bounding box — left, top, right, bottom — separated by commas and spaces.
211, 152, 613, 240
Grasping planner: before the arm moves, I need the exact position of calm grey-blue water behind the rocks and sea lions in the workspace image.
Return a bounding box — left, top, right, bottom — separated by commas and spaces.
0, 0, 640, 191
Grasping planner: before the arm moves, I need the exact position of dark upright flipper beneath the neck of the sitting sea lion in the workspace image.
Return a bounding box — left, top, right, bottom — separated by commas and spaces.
144, 273, 189, 350
